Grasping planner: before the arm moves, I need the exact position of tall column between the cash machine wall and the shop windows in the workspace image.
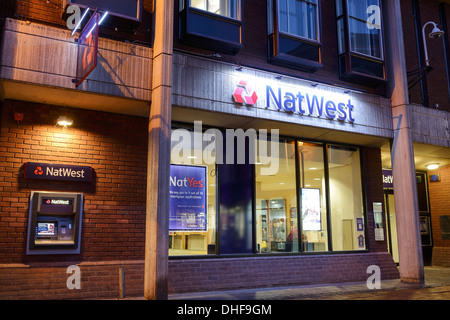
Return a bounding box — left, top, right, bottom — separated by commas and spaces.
144, 0, 174, 300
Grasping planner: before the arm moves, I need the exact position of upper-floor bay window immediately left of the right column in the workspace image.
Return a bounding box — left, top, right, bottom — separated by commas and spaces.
336, 0, 385, 85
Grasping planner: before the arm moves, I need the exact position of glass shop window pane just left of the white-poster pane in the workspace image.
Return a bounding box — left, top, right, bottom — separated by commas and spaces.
255, 140, 299, 253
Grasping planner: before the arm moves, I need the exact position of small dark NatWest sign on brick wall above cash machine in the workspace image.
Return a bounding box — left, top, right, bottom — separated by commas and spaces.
24, 162, 92, 182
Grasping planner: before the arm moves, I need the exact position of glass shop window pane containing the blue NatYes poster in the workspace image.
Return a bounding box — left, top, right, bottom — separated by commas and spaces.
169, 128, 217, 256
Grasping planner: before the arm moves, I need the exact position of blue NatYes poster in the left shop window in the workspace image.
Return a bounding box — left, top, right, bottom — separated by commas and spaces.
169, 164, 206, 231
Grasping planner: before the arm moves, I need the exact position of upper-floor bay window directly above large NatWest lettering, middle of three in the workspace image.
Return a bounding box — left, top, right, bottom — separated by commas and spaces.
267, 0, 322, 72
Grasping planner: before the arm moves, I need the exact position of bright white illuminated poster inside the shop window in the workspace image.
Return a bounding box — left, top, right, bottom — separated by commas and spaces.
301, 188, 322, 231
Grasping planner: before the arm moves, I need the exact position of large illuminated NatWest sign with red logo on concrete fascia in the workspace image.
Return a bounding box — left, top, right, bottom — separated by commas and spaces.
233, 80, 355, 123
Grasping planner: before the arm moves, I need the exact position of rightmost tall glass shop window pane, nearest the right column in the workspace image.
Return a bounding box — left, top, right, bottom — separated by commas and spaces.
327, 145, 366, 251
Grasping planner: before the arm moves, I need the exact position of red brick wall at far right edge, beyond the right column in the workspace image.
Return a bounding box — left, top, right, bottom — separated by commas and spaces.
428, 166, 450, 267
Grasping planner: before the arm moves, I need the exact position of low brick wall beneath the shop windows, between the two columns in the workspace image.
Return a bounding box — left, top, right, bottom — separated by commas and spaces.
169, 252, 399, 293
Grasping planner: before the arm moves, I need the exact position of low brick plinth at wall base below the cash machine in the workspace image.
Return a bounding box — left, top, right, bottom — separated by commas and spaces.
0, 261, 144, 300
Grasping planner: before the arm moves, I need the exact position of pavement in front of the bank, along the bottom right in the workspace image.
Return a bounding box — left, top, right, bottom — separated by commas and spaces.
169, 267, 450, 301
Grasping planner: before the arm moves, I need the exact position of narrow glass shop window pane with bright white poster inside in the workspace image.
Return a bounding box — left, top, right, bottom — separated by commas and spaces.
298, 141, 328, 252
